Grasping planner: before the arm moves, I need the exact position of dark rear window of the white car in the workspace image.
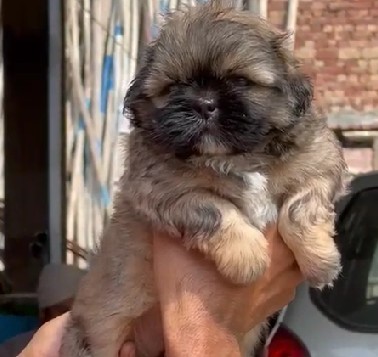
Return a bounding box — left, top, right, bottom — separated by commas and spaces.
311, 188, 378, 333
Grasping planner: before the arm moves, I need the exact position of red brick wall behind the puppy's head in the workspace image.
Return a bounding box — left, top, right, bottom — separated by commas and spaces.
268, 0, 378, 113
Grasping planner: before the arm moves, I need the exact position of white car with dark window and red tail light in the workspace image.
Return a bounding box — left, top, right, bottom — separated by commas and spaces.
264, 172, 378, 357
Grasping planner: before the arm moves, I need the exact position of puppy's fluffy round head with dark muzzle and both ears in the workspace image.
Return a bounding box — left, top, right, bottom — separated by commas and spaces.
125, 6, 312, 157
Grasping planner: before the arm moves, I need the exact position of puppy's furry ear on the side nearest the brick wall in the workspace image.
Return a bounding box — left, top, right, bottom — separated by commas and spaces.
273, 32, 314, 116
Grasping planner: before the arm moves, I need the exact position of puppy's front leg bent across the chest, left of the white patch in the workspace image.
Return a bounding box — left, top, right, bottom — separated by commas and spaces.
133, 190, 269, 283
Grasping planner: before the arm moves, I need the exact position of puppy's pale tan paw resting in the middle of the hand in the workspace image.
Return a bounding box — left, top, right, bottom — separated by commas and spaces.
210, 221, 270, 284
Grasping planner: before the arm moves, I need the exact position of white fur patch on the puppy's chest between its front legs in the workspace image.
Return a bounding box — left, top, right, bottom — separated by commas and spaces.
241, 172, 278, 230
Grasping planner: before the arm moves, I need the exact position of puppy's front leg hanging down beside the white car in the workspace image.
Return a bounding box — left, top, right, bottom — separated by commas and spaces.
278, 177, 341, 287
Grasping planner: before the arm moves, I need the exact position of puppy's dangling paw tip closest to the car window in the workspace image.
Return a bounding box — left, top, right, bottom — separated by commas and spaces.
296, 237, 341, 289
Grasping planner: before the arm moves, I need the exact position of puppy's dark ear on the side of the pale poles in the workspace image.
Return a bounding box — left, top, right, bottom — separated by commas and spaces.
123, 46, 154, 126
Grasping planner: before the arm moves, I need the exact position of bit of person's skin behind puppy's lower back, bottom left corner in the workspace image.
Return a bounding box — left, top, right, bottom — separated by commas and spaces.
18, 313, 69, 357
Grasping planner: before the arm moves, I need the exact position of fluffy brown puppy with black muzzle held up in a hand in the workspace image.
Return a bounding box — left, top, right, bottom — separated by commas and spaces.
60, 2, 346, 357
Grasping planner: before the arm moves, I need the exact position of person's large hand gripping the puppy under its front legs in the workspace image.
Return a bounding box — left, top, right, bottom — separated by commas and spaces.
121, 227, 303, 357
